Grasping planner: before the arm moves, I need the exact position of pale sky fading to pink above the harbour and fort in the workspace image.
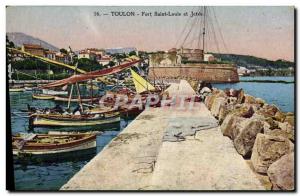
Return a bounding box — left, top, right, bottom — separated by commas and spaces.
6, 6, 294, 61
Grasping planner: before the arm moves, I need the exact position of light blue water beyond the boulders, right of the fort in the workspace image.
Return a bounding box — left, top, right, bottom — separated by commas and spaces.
213, 77, 295, 112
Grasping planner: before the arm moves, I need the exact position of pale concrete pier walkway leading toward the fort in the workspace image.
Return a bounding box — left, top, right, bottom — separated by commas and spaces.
61, 80, 264, 190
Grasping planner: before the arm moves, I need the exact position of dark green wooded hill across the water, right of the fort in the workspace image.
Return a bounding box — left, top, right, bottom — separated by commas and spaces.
213, 53, 295, 69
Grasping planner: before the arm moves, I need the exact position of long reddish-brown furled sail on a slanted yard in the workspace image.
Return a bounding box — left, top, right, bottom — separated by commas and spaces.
42, 58, 140, 88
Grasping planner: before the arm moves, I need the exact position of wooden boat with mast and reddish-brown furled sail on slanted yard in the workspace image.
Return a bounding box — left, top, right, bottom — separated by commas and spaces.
29, 59, 139, 128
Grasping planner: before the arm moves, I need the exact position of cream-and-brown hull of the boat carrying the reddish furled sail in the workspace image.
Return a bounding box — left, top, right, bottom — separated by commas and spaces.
29, 111, 120, 127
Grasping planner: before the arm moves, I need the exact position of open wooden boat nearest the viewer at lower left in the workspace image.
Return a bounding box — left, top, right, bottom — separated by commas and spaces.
12, 133, 96, 156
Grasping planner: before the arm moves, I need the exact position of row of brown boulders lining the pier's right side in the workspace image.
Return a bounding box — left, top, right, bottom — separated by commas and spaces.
204, 89, 295, 190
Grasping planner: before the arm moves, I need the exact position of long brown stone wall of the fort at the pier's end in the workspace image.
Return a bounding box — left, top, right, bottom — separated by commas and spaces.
148, 63, 239, 83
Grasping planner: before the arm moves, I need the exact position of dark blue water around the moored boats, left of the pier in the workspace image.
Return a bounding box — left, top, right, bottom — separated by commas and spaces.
10, 92, 131, 190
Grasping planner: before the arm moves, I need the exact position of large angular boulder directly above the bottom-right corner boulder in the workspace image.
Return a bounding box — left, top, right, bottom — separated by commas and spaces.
251, 133, 294, 173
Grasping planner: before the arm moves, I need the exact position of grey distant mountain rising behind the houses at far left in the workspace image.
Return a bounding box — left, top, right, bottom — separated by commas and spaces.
6, 32, 59, 51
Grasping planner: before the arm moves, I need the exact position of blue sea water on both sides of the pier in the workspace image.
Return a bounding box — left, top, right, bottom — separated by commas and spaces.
10, 77, 294, 190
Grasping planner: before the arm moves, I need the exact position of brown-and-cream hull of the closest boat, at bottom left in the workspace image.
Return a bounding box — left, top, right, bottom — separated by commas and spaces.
12, 134, 96, 161
